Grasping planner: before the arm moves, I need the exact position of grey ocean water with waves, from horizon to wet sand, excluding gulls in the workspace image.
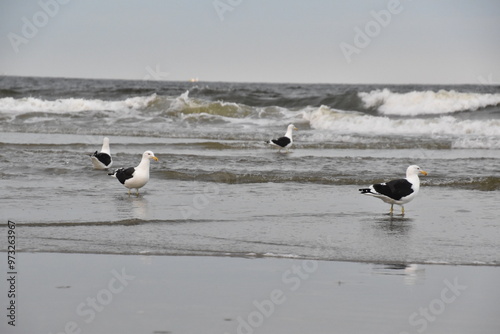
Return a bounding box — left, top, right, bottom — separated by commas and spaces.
0, 77, 500, 266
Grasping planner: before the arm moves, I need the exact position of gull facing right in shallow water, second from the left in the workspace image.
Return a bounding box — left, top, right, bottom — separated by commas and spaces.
108, 151, 158, 196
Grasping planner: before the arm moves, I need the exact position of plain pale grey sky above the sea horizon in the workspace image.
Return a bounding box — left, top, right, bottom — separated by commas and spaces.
0, 0, 500, 84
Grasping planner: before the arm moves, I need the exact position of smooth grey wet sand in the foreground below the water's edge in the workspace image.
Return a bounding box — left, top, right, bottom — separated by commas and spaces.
0, 253, 500, 334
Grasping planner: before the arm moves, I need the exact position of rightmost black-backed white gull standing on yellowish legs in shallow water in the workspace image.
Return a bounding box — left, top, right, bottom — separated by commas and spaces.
359, 165, 427, 216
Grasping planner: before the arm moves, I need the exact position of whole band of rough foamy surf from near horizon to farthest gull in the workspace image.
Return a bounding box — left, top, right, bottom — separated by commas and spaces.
0, 78, 500, 149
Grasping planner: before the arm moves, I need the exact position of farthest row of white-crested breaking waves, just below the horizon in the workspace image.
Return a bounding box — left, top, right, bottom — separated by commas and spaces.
0, 88, 500, 118
